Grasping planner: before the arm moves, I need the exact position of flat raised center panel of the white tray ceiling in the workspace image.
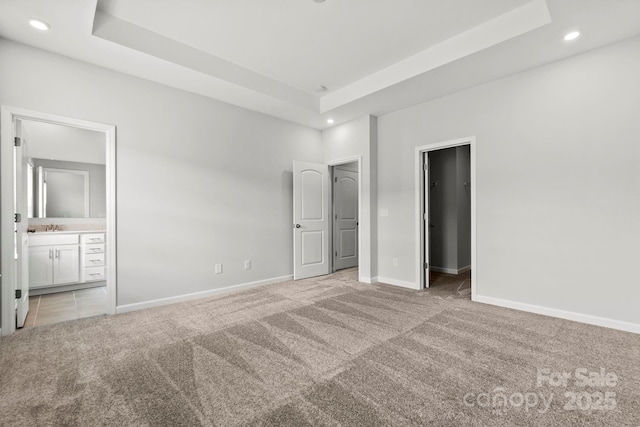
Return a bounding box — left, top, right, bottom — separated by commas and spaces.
98, 0, 530, 94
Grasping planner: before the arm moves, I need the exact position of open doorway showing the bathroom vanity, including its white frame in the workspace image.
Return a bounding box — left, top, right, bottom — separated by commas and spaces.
1, 107, 116, 335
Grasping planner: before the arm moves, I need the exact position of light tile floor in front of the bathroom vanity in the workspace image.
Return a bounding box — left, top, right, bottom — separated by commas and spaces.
24, 286, 107, 328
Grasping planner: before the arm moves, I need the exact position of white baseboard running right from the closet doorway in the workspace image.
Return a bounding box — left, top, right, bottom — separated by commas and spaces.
475, 295, 640, 334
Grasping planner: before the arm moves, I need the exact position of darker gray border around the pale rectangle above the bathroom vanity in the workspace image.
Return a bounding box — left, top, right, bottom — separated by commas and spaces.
33, 159, 107, 218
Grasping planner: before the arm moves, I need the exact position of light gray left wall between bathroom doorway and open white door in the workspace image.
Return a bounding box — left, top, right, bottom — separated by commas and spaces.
0, 39, 322, 305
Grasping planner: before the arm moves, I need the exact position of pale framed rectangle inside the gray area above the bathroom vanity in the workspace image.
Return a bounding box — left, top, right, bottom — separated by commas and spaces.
36, 166, 89, 218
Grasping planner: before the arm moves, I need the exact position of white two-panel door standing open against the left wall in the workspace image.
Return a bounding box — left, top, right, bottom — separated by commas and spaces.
293, 161, 331, 280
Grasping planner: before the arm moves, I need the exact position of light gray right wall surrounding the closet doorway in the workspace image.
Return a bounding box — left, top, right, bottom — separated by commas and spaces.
378, 38, 640, 324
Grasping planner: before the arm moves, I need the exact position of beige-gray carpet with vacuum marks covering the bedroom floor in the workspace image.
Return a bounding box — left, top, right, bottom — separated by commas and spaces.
0, 270, 640, 427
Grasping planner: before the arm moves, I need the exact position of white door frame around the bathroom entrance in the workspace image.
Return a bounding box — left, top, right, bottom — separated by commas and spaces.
0, 105, 117, 335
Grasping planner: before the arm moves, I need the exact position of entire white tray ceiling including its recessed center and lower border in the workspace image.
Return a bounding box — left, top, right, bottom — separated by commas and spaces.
0, 0, 640, 128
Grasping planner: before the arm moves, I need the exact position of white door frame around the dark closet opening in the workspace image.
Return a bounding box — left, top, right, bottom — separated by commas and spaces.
415, 136, 478, 301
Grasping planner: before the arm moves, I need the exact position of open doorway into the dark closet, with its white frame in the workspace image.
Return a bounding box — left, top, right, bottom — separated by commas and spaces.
416, 137, 476, 299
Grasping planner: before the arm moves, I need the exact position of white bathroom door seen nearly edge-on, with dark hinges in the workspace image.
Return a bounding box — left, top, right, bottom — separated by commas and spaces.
13, 120, 29, 328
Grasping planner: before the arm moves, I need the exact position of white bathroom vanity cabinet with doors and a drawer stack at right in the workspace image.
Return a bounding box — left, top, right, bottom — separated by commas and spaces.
29, 232, 105, 289
